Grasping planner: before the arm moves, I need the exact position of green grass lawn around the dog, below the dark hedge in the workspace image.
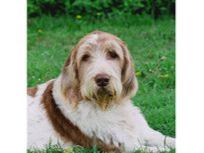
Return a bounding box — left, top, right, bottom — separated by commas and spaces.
27, 16, 175, 153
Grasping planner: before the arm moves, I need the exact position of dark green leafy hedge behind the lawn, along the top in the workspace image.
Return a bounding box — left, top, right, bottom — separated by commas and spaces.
28, 0, 175, 18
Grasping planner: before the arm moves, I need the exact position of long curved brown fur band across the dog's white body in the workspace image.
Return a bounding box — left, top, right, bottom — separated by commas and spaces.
42, 82, 120, 152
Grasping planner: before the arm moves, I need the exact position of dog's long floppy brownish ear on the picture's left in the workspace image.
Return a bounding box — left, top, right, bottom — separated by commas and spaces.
61, 47, 81, 106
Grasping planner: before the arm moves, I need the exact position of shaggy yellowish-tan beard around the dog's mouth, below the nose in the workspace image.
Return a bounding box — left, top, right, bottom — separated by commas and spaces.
81, 80, 122, 110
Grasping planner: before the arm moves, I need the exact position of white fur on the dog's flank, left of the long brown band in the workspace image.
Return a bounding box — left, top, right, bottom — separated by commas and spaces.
27, 81, 67, 148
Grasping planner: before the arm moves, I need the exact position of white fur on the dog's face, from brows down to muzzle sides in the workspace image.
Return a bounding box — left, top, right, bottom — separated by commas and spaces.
77, 34, 123, 99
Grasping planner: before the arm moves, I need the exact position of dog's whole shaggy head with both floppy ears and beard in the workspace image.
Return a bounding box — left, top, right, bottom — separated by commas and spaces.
62, 31, 137, 109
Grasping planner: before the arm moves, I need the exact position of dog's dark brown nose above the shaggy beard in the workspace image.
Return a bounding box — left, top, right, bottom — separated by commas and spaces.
95, 73, 110, 87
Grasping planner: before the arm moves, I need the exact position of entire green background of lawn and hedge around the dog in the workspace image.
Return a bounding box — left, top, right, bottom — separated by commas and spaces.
27, 0, 175, 153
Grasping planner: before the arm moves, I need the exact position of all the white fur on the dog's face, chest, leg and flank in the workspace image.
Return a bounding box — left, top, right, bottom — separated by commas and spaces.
28, 34, 175, 152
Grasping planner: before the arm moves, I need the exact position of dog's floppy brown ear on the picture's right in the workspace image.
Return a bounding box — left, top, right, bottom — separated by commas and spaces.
120, 41, 138, 98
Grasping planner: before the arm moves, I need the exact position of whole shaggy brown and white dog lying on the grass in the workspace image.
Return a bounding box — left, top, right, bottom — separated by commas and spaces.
28, 31, 175, 152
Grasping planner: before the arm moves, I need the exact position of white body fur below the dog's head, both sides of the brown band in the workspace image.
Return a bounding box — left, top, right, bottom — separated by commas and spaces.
28, 77, 175, 152
